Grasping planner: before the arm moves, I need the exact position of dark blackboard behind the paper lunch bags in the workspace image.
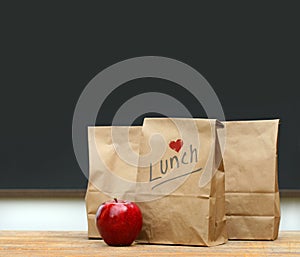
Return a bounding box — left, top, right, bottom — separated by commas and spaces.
0, 1, 300, 189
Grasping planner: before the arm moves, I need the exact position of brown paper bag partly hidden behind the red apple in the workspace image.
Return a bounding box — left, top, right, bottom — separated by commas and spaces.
85, 127, 141, 238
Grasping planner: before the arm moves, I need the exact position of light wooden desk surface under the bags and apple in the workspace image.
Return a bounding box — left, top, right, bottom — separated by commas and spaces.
0, 231, 300, 257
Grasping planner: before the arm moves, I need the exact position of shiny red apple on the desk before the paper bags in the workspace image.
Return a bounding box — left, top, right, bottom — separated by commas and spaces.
96, 198, 143, 246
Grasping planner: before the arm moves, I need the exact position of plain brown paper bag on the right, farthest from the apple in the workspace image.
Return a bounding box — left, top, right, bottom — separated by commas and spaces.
223, 120, 280, 240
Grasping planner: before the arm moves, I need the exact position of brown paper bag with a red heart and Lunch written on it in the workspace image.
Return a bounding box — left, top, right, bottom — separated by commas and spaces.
137, 118, 227, 246
